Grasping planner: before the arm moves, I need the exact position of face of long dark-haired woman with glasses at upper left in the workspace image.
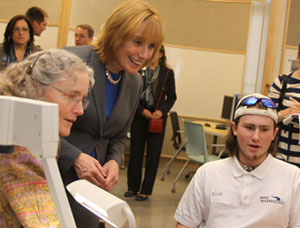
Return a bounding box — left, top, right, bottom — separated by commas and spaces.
12, 19, 30, 45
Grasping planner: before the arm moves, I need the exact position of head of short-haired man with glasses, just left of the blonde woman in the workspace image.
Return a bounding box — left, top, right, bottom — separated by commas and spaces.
75, 24, 94, 46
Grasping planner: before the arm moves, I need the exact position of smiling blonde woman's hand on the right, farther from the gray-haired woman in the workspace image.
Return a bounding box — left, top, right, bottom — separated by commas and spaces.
101, 160, 119, 192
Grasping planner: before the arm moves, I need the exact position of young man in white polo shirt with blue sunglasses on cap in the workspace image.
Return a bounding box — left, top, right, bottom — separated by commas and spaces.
174, 94, 300, 228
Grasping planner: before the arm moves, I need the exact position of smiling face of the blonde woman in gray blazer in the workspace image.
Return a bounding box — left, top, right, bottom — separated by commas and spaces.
112, 22, 156, 74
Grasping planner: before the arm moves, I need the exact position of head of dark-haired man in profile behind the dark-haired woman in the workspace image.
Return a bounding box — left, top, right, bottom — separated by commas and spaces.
25, 6, 48, 36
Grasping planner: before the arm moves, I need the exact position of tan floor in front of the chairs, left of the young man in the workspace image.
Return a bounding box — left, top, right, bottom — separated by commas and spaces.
106, 160, 197, 228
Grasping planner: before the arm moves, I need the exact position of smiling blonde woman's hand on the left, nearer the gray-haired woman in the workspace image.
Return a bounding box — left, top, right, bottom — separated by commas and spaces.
74, 153, 106, 187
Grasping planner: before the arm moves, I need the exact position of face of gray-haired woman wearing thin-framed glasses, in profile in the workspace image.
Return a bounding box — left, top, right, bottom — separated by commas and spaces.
43, 72, 89, 136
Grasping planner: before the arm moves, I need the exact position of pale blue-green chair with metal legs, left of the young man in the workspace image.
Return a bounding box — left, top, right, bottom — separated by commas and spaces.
172, 121, 224, 193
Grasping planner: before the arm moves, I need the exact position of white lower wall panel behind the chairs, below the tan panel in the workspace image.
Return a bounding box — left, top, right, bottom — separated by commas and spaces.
166, 47, 245, 118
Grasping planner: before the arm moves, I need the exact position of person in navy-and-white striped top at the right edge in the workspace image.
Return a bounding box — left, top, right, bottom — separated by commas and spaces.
268, 44, 300, 168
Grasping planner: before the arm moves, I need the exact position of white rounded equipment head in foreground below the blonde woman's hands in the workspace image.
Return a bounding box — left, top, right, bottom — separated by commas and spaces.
67, 179, 136, 228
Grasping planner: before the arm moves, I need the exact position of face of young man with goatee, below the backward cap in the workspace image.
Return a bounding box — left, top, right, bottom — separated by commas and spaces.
232, 115, 278, 166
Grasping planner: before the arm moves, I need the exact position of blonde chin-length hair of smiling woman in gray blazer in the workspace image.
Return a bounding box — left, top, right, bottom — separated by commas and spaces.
94, 0, 164, 65
